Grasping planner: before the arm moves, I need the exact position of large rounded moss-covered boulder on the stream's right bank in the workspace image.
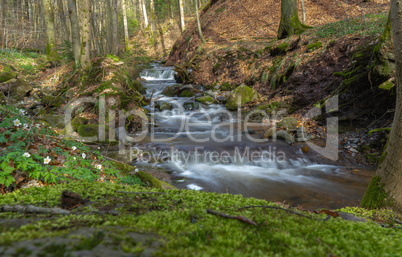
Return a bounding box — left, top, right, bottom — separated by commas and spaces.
225, 84, 259, 111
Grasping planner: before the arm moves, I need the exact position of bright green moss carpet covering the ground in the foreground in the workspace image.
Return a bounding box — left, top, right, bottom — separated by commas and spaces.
0, 181, 402, 256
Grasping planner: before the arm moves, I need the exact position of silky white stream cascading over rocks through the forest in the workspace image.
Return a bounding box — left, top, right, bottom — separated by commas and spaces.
136, 65, 370, 208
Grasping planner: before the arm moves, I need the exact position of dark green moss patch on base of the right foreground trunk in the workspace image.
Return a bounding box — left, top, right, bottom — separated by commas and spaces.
361, 176, 387, 209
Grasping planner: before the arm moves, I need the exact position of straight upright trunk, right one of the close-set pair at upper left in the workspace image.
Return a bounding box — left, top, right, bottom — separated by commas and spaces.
80, 0, 92, 69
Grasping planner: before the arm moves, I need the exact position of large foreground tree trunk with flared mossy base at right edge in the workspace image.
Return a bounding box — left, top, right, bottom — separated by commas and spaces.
362, 0, 402, 213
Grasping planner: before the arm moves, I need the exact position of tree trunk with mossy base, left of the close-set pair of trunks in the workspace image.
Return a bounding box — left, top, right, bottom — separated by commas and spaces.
42, 0, 59, 62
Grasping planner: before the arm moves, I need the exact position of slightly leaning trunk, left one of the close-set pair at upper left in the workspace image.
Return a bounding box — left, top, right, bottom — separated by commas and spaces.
68, 0, 81, 68
